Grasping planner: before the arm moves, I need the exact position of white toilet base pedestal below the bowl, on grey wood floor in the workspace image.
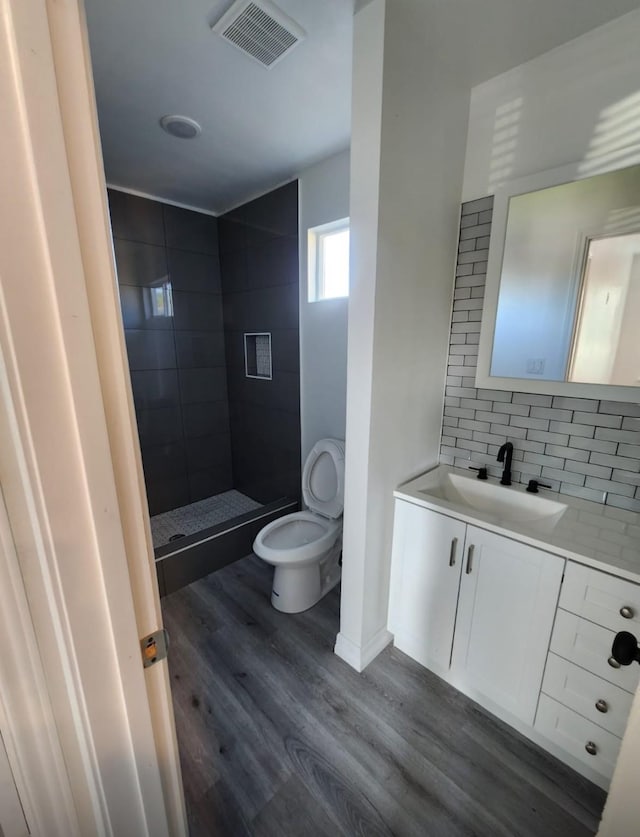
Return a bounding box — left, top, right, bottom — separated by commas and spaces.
271, 538, 342, 613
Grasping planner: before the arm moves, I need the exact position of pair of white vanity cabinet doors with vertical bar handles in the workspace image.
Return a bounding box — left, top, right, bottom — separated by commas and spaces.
389, 500, 565, 724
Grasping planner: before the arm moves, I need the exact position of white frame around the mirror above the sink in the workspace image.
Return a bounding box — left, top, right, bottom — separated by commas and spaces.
476, 163, 640, 403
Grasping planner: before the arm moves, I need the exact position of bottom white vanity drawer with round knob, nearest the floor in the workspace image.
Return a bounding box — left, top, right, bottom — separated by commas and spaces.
534, 695, 621, 779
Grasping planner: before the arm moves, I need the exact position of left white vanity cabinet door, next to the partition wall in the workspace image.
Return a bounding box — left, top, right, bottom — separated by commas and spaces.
389, 500, 466, 672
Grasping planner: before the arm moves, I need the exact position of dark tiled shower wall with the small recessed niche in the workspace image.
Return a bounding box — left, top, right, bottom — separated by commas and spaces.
218, 182, 301, 503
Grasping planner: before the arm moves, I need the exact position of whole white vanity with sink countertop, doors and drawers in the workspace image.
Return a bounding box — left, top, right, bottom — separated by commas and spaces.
389, 465, 640, 789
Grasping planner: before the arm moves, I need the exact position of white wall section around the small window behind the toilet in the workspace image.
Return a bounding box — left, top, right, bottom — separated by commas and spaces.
299, 151, 349, 463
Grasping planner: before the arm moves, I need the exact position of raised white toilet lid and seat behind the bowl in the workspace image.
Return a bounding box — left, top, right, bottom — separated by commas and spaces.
302, 439, 344, 520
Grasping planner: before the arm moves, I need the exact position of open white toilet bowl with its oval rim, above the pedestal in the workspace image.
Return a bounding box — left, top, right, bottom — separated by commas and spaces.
253, 511, 341, 566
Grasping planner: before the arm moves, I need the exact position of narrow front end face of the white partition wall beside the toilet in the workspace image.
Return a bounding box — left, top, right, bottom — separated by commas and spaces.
336, 0, 385, 671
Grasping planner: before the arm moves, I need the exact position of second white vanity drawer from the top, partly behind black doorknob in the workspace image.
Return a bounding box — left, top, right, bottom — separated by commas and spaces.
551, 608, 640, 693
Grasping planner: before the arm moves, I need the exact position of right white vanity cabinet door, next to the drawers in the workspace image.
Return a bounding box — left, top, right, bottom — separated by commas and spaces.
452, 526, 564, 724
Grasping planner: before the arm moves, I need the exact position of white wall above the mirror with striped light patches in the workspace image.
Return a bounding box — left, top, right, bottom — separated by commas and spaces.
462, 10, 640, 201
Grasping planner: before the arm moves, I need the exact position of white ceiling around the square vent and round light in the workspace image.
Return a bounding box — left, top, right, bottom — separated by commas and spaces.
85, 0, 638, 214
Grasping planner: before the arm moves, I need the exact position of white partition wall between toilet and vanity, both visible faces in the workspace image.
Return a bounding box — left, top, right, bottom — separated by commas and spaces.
336, 0, 470, 667
